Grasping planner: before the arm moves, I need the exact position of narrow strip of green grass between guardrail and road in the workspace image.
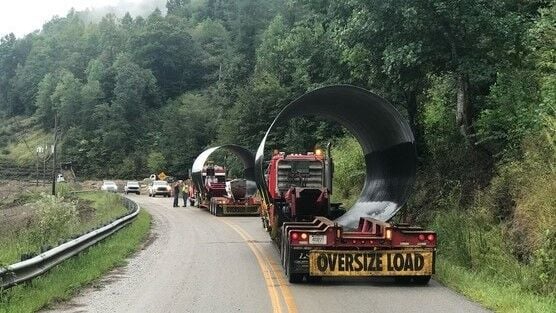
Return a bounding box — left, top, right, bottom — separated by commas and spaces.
0, 207, 151, 313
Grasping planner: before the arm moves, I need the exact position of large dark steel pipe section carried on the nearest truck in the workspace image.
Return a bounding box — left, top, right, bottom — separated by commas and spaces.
255, 85, 417, 228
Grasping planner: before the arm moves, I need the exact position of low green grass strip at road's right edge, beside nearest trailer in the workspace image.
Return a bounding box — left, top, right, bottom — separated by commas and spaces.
435, 257, 556, 313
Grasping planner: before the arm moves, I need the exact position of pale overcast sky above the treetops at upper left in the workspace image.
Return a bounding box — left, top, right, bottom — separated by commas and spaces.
0, 0, 166, 37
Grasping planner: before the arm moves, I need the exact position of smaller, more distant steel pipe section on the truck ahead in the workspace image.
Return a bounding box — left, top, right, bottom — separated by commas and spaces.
191, 144, 255, 194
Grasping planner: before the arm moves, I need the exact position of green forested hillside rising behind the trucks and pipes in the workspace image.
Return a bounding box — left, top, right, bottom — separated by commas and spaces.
0, 0, 556, 306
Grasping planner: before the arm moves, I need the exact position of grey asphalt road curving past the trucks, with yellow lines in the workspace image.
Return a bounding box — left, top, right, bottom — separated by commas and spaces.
48, 195, 486, 313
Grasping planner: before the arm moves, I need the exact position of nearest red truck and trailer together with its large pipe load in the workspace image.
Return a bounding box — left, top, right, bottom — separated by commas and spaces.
255, 85, 437, 284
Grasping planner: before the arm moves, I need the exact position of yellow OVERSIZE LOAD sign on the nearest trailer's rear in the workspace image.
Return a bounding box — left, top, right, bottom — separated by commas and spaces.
309, 250, 433, 276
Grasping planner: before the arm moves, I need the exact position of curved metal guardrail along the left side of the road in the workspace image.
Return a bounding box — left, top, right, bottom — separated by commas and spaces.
0, 198, 139, 289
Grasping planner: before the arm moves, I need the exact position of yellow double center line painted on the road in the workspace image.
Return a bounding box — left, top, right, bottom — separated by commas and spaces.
220, 218, 297, 313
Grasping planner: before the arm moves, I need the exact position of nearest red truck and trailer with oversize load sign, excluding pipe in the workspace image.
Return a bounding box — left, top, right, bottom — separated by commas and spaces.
262, 152, 436, 284
